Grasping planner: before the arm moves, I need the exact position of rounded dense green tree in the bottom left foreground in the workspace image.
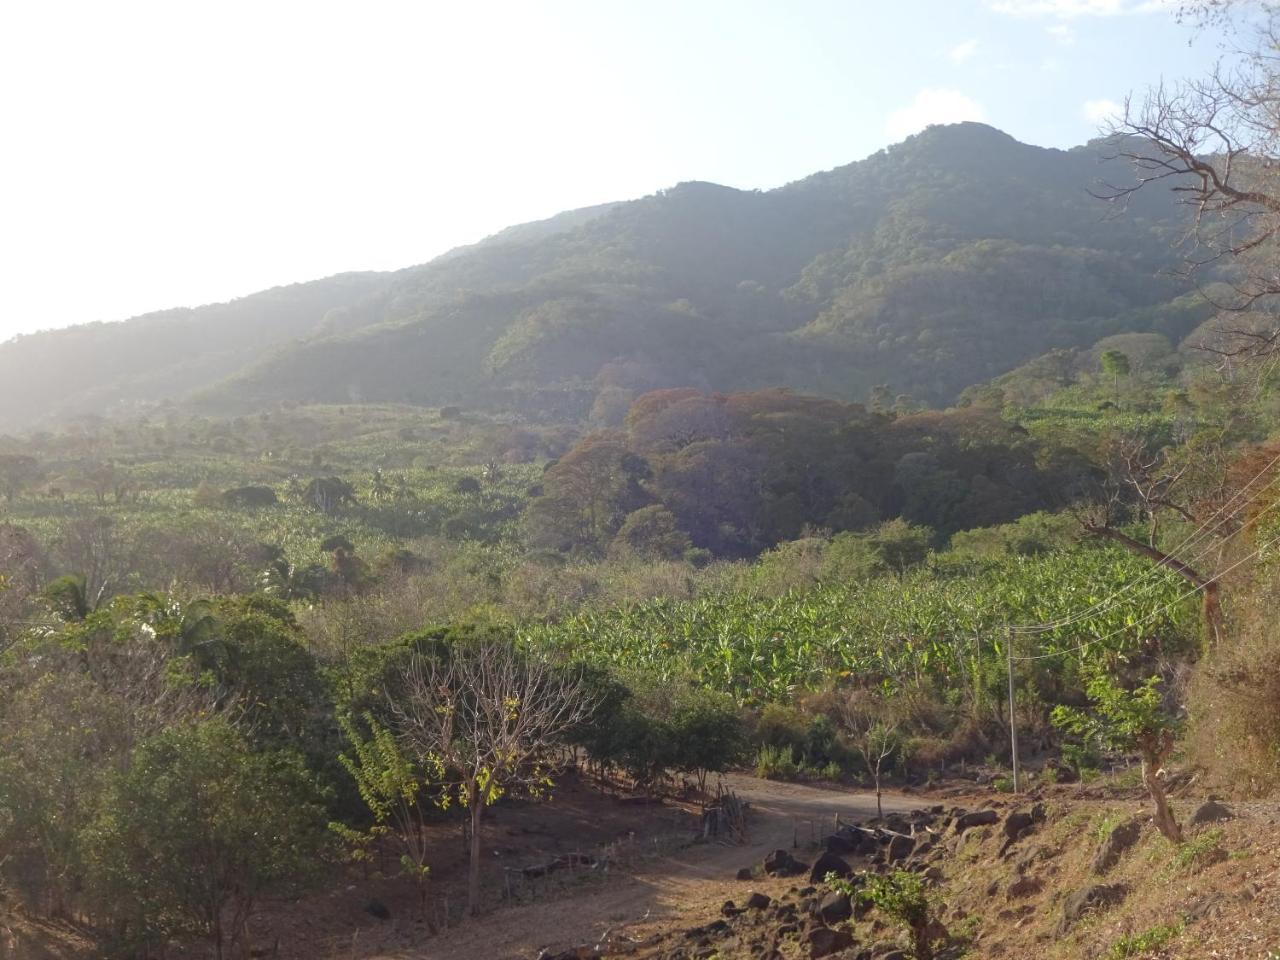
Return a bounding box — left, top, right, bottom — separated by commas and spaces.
84, 719, 324, 960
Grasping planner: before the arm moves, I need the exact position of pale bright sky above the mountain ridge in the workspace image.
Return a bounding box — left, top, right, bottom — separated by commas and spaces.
0, 0, 1217, 340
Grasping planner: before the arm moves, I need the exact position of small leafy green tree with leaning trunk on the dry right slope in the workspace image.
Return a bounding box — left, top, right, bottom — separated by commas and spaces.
1052, 669, 1183, 844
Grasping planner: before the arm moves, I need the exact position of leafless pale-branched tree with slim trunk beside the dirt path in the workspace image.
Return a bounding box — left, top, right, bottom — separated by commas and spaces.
390, 637, 594, 914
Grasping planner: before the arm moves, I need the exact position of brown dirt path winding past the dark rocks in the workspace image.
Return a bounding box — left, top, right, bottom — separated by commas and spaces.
380, 774, 920, 960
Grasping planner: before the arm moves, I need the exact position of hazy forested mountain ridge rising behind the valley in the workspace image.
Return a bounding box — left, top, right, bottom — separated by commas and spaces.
0, 123, 1189, 429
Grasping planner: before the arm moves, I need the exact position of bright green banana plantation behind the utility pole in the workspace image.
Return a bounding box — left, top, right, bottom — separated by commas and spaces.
522, 545, 1194, 704
